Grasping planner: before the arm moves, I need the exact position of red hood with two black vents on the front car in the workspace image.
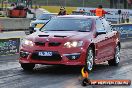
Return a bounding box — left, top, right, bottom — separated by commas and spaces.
27, 31, 92, 42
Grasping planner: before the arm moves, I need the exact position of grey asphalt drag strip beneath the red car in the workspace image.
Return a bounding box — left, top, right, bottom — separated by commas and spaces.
0, 31, 132, 88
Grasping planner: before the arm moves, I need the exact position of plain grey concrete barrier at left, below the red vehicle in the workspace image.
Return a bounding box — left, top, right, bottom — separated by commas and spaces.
0, 18, 31, 31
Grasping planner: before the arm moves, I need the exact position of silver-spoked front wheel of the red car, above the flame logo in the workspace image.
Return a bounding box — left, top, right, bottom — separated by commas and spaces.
86, 47, 94, 72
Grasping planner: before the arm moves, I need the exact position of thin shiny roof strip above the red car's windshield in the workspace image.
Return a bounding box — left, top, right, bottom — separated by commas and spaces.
57, 15, 100, 19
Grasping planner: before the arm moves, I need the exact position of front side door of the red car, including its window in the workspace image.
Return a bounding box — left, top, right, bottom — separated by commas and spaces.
94, 18, 108, 63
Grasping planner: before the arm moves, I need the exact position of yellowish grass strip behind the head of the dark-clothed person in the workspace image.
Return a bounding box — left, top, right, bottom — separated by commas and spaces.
41, 6, 77, 14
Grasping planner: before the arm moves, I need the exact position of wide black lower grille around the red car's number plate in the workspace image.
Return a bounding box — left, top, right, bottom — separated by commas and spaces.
31, 52, 62, 61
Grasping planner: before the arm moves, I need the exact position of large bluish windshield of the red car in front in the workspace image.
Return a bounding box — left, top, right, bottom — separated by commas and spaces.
41, 18, 92, 32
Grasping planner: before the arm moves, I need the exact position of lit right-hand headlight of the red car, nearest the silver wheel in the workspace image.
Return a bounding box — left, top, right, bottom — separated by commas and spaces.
64, 41, 83, 48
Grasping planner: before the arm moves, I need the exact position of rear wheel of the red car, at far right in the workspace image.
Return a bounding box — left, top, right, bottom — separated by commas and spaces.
108, 45, 120, 66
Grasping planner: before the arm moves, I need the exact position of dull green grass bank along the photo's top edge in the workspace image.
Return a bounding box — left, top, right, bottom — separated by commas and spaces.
33, 0, 109, 7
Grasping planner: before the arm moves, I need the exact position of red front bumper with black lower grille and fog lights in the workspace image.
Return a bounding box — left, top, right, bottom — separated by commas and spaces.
19, 47, 87, 65
